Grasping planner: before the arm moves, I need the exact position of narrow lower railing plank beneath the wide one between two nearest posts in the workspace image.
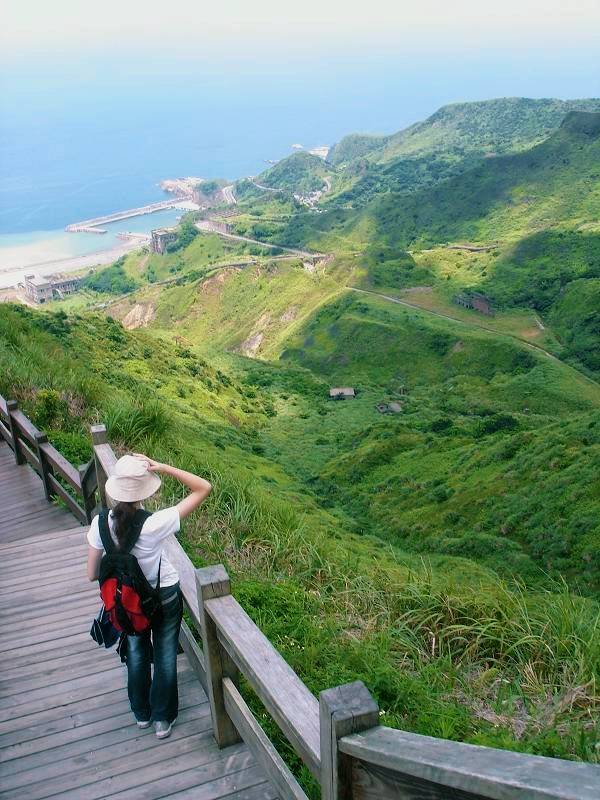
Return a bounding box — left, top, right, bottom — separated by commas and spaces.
223, 678, 307, 800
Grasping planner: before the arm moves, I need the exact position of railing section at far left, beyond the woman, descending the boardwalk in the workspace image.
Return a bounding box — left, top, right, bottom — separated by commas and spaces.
0, 395, 96, 524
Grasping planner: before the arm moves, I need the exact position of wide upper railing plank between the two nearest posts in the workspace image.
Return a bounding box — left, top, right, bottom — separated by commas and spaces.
204, 595, 321, 778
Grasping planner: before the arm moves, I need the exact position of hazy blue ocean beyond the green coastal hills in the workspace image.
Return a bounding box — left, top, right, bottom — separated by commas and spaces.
0, 47, 596, 285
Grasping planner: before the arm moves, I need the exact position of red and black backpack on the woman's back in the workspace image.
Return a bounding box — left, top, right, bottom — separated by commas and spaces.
98, 509, 162, 636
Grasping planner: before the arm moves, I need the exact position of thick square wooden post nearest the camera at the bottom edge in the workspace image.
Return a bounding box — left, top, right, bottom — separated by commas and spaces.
319, 681, 379, 800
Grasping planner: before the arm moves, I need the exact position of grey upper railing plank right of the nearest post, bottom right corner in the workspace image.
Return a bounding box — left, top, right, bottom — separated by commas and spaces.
339, 727, 600, 800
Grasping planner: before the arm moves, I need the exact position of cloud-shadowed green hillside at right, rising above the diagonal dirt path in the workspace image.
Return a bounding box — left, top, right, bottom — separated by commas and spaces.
254, 112, 600, 371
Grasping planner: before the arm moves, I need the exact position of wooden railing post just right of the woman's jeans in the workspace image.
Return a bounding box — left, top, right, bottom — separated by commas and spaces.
196, 564, 241, 747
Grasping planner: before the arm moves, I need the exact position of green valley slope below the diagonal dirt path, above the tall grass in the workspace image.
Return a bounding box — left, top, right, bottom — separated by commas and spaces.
276, 296, 600, 592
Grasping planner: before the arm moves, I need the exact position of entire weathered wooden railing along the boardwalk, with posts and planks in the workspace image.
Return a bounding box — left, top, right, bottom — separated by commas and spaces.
0, 397, 600, 800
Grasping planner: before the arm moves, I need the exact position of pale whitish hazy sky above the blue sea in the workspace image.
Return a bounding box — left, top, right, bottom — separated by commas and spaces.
0, 0, 600, 57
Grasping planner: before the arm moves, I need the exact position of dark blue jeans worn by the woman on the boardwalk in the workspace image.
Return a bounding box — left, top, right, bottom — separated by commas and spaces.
127, 583, 183, 722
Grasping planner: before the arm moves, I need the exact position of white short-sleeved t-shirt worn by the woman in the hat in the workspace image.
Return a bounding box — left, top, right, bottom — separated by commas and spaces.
87, 506, 180, 588
